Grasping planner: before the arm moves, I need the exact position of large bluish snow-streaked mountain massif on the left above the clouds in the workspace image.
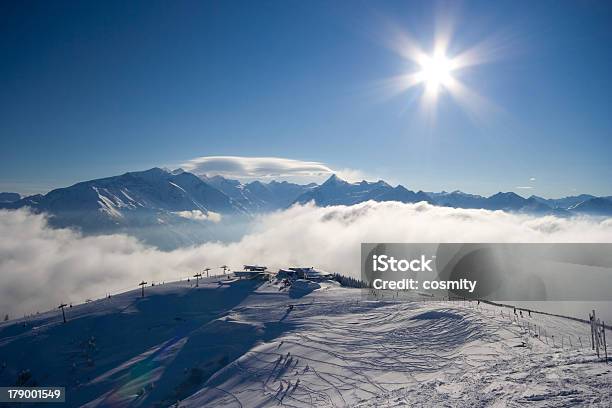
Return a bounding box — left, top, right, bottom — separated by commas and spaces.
0, 168, 247, 248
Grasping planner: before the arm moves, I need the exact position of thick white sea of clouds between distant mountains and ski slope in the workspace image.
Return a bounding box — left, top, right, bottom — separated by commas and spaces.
0, 202, 612, 316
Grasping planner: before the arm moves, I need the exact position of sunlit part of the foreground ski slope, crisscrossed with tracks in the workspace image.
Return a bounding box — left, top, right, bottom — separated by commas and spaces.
180, 288, 612, 407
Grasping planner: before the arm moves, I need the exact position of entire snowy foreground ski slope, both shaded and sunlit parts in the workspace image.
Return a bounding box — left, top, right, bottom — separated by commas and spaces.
0, 278, 612, 407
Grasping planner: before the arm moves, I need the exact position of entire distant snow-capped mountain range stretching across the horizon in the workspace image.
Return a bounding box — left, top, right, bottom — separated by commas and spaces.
0, 168, 612, 248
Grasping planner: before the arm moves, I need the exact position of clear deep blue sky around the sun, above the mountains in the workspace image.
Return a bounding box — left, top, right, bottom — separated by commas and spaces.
0, 1, 612, 196
